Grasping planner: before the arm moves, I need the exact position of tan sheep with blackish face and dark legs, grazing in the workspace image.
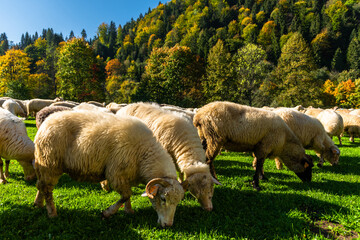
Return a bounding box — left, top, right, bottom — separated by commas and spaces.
193, 102, 313, 190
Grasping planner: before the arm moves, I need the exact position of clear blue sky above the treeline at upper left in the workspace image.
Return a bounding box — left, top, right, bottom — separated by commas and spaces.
0, 0, 161, 44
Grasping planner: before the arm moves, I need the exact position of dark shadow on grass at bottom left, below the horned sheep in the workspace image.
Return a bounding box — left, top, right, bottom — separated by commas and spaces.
0, 205, 143, 239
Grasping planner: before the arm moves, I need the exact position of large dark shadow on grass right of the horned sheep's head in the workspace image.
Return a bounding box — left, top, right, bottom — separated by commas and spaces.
173, 187, 349, 239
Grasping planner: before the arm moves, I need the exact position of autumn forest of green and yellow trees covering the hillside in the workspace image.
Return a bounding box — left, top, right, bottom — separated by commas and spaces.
0, 0, 360, 108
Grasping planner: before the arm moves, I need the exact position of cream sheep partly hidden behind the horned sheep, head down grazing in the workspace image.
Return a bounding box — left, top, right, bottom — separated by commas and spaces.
116, 103, 220, 211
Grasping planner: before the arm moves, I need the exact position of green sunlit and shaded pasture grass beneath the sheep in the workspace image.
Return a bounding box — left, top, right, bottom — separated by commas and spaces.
0, 120, 360, 240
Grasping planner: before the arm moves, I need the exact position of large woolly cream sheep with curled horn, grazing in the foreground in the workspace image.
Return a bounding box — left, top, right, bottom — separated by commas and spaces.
34, 111, 184, 227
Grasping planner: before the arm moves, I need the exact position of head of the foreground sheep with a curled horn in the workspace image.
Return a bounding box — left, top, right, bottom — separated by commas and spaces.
143, 178, 184, 227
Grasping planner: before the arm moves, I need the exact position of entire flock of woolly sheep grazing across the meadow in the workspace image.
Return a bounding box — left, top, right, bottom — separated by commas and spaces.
0, 95, 360, 227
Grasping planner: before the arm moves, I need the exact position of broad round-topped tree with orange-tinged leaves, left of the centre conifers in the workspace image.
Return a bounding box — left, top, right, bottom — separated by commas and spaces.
145, 45, 204, 106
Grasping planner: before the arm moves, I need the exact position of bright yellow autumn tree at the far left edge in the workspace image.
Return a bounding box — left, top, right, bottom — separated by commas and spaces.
0, 49, 30, 99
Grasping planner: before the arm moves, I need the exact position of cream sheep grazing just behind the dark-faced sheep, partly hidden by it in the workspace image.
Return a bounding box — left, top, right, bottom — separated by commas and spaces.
274, 109, 340, 168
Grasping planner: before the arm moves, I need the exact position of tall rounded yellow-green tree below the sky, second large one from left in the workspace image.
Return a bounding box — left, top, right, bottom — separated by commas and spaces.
56, 38, 105, 101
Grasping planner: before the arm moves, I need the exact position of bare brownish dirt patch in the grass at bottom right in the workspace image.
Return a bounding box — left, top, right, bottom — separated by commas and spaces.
311, 221, 360, 240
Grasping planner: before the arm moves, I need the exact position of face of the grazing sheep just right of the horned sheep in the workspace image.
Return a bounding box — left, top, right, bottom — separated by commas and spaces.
182, 173, 217, 211
